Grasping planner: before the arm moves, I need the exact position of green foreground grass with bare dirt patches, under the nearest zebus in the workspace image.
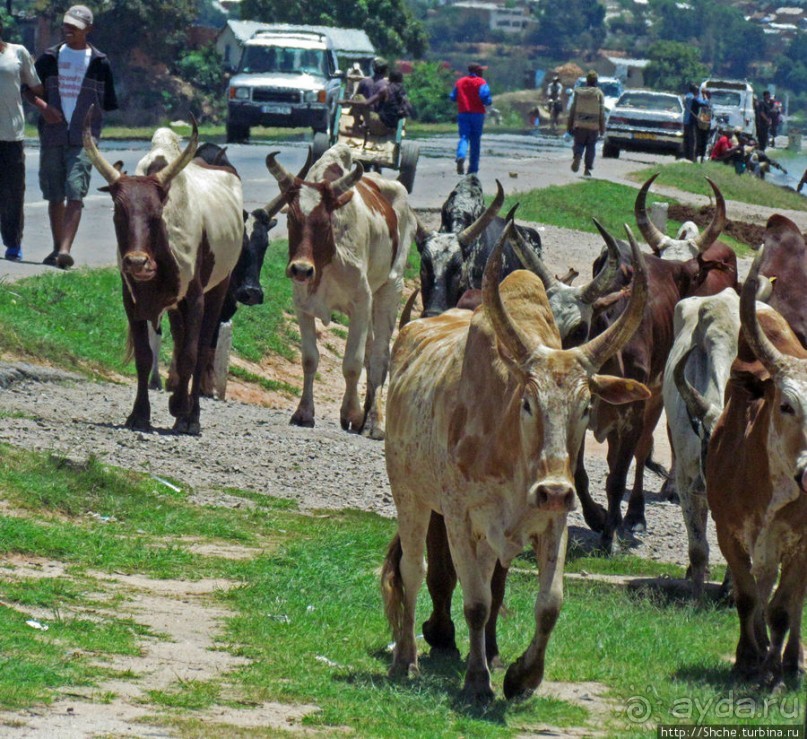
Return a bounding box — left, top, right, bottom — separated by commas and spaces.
0, 446, 800, 737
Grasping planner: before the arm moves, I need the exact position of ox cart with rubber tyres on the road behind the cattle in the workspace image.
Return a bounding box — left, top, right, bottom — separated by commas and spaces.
314, 105, 420, 193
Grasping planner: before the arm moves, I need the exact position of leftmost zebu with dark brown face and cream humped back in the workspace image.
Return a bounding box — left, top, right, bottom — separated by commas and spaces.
84, 114, 244, 434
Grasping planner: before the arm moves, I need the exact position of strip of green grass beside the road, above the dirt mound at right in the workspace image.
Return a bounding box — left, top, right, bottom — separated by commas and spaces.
630, 162, 807, 211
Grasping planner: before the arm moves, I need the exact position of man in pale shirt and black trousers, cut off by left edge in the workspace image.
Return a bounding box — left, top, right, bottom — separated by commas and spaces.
0, 18, 48, 262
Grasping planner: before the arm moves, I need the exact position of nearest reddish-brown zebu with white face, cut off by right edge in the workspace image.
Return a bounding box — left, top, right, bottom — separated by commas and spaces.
706, 249, 807, 686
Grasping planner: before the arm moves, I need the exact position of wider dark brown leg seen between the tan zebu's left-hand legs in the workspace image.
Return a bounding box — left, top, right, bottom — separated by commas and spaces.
423, 511, 459, 657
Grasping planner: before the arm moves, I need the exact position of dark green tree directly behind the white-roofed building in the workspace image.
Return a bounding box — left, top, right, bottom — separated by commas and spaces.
241, 0, 427, 59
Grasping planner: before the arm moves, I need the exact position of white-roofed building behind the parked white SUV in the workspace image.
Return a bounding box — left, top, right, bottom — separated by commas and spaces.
216, 20, 376, 71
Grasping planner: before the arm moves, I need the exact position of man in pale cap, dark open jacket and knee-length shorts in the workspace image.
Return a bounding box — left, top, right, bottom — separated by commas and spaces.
34, 5, 118, 269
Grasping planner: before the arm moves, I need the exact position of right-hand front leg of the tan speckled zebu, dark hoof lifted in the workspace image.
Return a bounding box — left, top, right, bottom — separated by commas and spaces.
504, 515, 567, 699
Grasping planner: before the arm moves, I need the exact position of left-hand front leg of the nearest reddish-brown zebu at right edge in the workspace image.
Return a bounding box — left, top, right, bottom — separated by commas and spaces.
717, 527, 767, 679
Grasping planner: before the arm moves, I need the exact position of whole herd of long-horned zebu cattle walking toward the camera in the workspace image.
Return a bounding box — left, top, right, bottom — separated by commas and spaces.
84, 110, 807, 702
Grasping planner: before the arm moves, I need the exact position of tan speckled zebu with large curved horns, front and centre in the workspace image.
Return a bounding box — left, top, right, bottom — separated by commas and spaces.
382, 225, 648, 702
